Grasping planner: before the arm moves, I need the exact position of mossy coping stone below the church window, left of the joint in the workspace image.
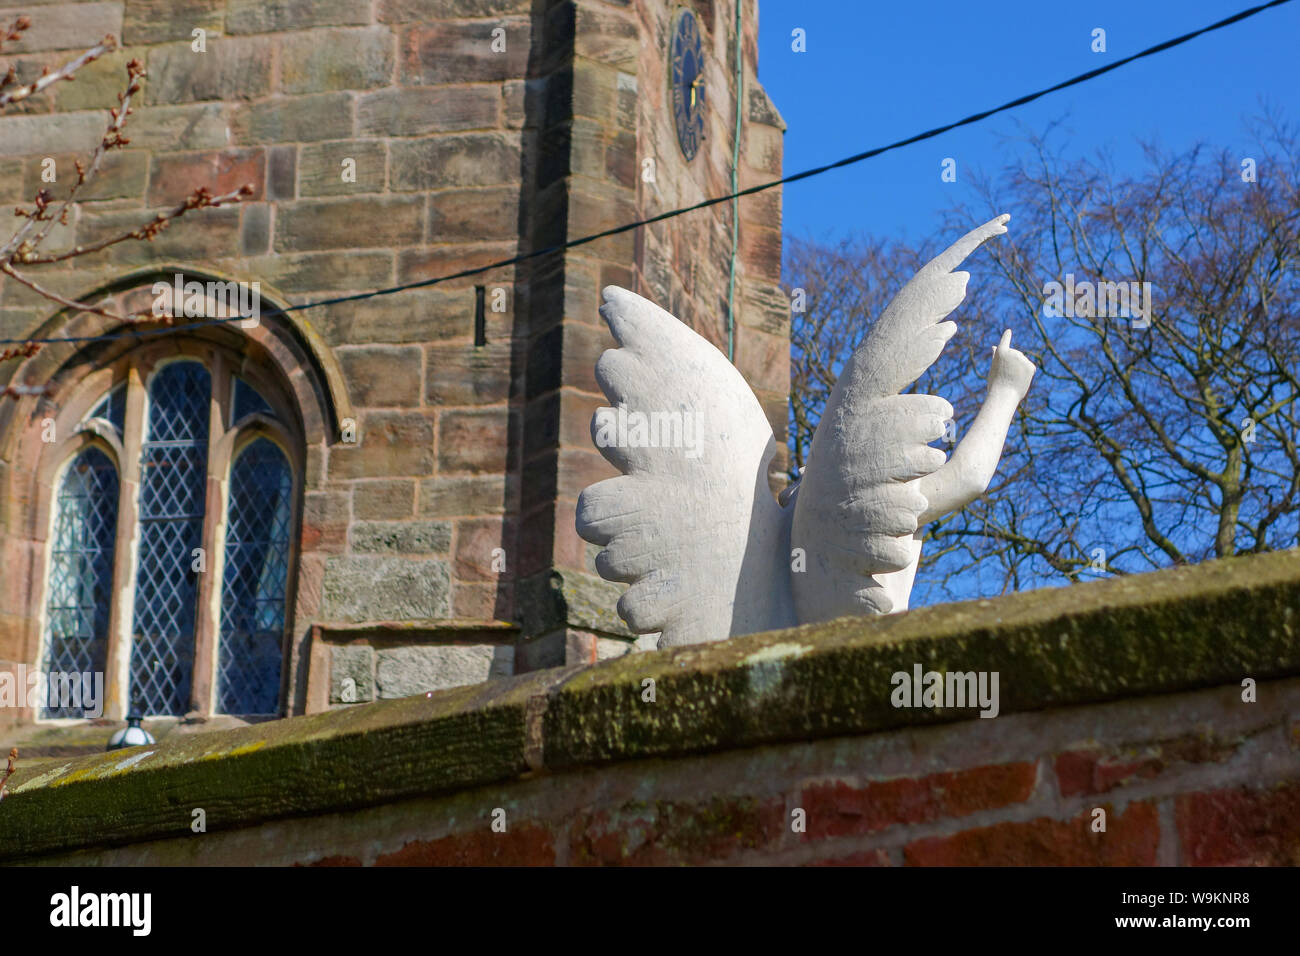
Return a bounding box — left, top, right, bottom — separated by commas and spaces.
0, 671, 569, 860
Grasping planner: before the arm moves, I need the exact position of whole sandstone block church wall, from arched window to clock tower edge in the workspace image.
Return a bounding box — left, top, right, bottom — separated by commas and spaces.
0, 0, 788, 719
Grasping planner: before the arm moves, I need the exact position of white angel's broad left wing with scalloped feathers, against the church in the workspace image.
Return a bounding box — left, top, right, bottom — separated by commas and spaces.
577, 286, 794, 646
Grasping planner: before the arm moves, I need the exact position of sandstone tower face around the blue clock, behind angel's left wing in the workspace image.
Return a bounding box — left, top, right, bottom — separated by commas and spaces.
520, 0, 789, 667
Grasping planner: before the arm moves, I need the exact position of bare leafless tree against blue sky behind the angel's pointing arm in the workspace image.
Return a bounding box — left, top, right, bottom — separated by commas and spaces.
788, 121, 1300, 602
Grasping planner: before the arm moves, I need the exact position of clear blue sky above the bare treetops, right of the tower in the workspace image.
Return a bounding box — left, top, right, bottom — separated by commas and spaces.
759, 0, 1300, 242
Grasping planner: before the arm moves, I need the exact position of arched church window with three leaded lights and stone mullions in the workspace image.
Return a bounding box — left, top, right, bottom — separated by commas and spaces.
40, 342, 302, 717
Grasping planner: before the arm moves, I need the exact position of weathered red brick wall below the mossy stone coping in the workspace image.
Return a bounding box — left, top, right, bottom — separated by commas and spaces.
35, 678, 1300, 866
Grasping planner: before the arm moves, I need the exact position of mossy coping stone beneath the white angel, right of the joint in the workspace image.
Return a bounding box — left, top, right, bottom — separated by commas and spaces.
543, 551, 1300, 769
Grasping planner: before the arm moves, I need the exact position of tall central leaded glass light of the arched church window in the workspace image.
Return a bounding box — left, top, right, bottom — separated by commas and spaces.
130, 362, 212, 715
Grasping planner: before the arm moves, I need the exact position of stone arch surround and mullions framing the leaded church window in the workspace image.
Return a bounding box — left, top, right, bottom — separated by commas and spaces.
0, 263, 356, 722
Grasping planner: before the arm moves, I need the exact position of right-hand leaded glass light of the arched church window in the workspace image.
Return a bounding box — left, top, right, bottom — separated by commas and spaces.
217, 438, 294, 714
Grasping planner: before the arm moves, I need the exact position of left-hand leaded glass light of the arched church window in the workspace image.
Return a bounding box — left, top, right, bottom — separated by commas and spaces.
40, 447, 118, 717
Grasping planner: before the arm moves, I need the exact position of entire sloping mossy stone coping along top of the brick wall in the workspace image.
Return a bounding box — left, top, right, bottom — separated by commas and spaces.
0, 551, 1300, 860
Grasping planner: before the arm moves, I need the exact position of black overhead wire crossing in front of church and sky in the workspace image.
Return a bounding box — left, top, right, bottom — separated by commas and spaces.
0, 0, 1291, 345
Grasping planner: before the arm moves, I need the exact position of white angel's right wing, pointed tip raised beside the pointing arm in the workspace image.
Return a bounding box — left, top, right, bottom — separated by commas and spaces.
790, 215, 1010, 623
